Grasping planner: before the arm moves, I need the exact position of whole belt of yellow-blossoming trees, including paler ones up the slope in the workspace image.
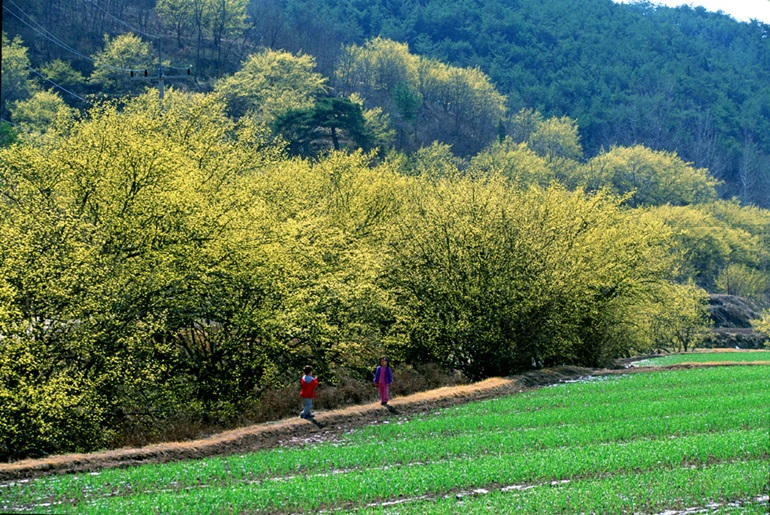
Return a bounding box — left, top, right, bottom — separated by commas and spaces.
0, 22, 770, 458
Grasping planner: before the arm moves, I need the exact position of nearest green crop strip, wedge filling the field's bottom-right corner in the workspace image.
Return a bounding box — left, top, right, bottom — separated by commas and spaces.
353, 461, 768, 515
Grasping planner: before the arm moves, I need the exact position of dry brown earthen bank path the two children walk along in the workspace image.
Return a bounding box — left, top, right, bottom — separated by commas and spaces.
0, 363, 760, 481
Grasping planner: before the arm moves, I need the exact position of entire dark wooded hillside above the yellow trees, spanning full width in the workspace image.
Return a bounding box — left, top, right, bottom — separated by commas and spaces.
3, 0, 770, 207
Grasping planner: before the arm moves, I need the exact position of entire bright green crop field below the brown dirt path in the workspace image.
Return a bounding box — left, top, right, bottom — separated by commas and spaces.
0, 366, 770, 514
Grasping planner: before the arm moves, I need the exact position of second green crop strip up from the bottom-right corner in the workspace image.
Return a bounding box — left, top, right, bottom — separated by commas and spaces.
18, 429, 770, 513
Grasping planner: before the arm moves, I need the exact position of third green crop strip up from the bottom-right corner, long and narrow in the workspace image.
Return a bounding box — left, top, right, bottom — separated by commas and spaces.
10, 404, 767, 508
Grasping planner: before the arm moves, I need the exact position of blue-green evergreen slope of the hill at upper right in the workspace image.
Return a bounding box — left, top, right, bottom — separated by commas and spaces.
272, 0, 770, 206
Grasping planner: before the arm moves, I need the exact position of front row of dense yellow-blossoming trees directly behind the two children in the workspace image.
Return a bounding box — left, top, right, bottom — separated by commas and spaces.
0, 83, 744, 457
